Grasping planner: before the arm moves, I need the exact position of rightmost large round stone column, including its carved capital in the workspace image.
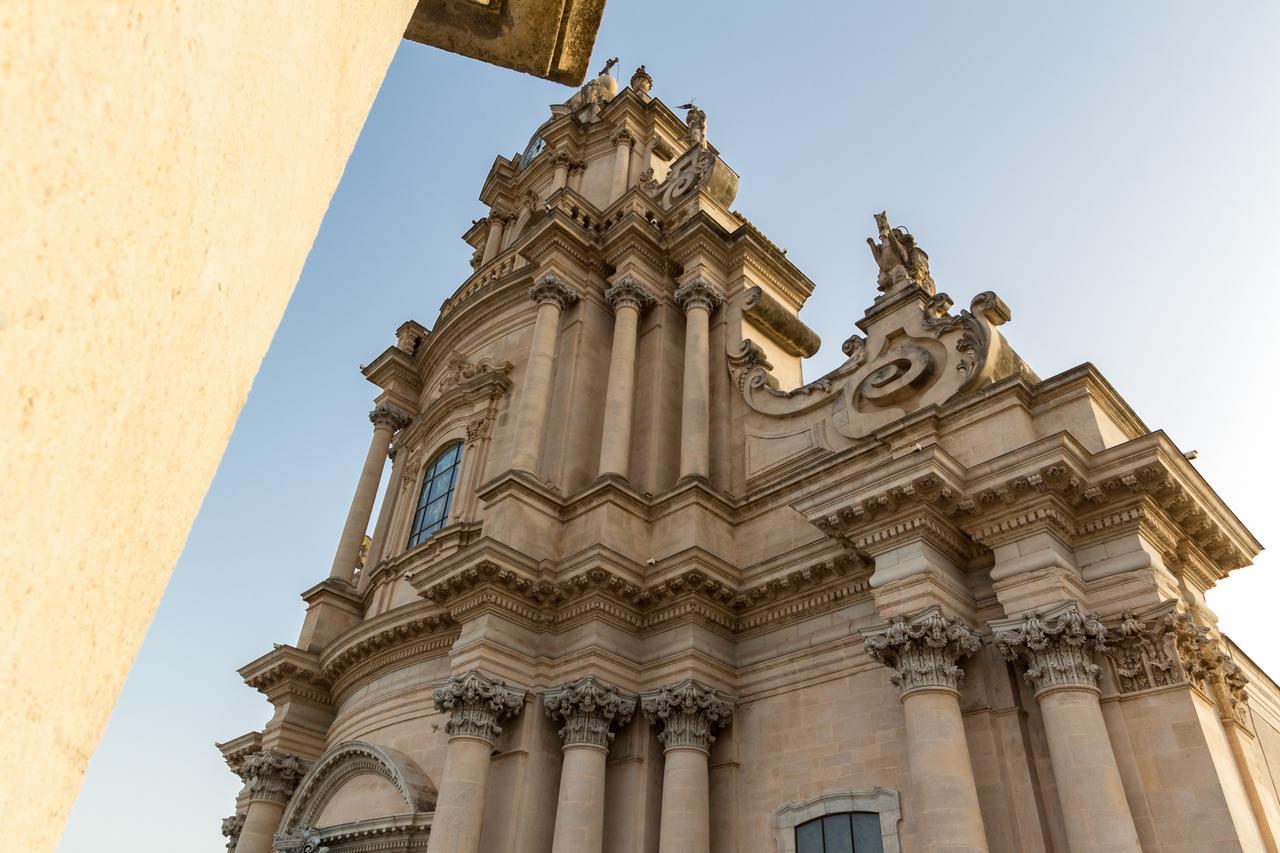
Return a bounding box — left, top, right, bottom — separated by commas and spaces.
991, 601, 1142, 853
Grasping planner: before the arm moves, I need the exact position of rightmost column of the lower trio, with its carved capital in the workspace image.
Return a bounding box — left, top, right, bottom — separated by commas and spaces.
640, 679, 733, 853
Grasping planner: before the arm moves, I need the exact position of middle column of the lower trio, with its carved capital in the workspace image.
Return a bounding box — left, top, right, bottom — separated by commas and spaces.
543, 676, 636, 853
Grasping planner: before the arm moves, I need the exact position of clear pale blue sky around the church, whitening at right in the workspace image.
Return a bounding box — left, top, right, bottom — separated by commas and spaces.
55, 0, 1280, 853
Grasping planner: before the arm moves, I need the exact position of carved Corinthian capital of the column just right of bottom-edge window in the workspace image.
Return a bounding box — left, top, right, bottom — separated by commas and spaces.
863, 605, 982, 697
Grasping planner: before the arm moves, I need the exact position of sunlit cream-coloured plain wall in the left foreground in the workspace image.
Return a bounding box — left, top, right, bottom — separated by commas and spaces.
0, 0, 415, 850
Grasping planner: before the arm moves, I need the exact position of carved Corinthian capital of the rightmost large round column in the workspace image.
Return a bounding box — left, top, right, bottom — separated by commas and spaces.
991, 601, 1107, 694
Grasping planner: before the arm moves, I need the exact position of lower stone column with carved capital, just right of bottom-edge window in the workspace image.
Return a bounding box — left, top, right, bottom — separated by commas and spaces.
863, 606, 987, 853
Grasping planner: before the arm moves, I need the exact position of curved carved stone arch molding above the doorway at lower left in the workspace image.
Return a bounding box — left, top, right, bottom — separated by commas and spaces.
280, 740, 436, 834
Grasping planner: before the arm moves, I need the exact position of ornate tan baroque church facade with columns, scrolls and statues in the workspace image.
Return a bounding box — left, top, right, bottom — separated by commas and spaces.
219, 67, 1280, 853
